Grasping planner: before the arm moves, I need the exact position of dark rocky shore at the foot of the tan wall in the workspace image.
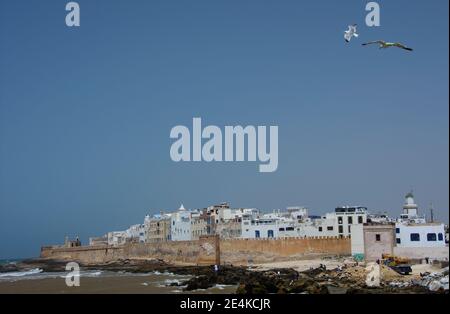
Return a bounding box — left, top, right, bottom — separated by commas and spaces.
0, 259, 448, 294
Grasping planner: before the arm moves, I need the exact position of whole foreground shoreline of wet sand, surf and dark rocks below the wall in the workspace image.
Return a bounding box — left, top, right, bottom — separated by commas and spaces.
0, 258, 448, 294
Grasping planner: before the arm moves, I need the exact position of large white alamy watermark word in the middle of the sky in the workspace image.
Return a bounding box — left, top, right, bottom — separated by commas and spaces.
170, 118, 278, 172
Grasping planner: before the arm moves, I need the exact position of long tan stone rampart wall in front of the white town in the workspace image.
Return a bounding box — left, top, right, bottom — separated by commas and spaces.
41, 236, 351, 265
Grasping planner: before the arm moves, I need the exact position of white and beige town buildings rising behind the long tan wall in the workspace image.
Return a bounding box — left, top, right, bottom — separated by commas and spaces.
86, 191, 448, 247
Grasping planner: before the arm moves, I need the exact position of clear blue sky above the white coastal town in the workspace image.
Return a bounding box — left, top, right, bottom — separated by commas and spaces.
0, 0, 449, 258
